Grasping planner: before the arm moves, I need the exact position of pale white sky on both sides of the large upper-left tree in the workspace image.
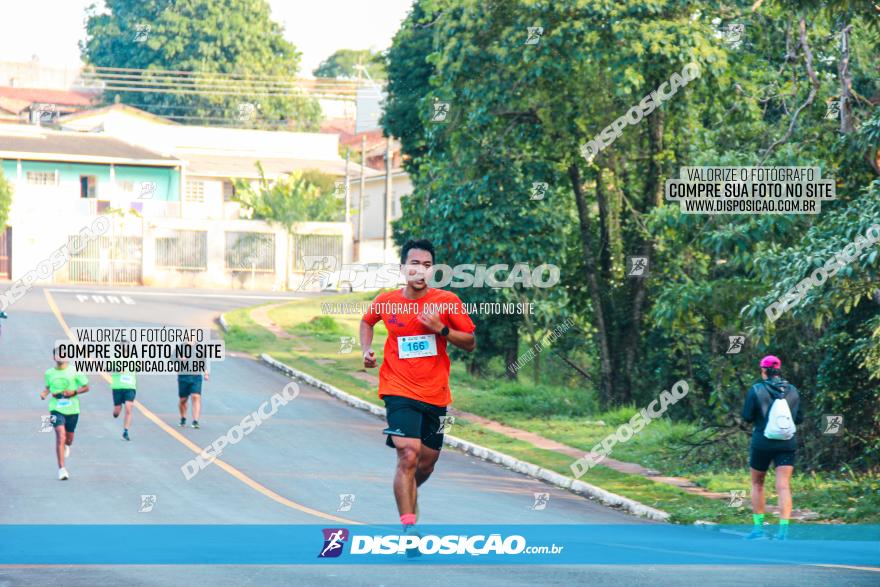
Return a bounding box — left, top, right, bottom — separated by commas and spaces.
0, 0, 412, 77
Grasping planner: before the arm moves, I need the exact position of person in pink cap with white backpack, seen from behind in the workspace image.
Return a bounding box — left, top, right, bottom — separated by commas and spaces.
742, 355, 803, 540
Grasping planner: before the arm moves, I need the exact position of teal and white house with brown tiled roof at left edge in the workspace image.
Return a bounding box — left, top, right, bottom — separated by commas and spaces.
0, 125, 183, 281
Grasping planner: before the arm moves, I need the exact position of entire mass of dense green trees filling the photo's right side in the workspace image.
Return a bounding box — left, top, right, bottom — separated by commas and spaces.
383, 0, 880, 446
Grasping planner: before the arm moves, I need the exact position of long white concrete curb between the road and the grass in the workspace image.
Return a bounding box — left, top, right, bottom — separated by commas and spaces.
258, 352, 669, 522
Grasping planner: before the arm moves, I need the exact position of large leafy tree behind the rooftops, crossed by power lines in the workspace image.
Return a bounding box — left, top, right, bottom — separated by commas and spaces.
80, 0, 321, 131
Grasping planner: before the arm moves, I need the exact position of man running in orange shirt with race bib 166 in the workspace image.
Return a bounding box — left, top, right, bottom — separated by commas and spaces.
360, 240, 477, 532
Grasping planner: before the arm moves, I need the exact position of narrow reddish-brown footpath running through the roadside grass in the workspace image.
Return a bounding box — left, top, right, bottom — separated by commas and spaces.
250, 302, 819, 521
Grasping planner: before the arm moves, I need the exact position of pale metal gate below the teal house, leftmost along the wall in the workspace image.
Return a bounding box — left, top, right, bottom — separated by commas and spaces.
67, 234, 143, 285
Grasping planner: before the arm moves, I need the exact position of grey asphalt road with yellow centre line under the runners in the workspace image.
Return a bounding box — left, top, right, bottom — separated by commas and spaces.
0, 287, 880, 587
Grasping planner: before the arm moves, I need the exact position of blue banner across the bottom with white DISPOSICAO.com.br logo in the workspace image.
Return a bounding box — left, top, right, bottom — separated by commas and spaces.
0, 524, 880, 566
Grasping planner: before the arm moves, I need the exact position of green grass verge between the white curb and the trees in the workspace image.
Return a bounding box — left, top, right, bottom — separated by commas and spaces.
220, 293, 880, 524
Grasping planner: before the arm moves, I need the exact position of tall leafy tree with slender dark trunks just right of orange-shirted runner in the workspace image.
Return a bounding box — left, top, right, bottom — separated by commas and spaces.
385, 0, 724, 402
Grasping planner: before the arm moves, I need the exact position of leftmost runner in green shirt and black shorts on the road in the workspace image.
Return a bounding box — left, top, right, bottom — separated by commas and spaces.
40, 353, 89, 481
